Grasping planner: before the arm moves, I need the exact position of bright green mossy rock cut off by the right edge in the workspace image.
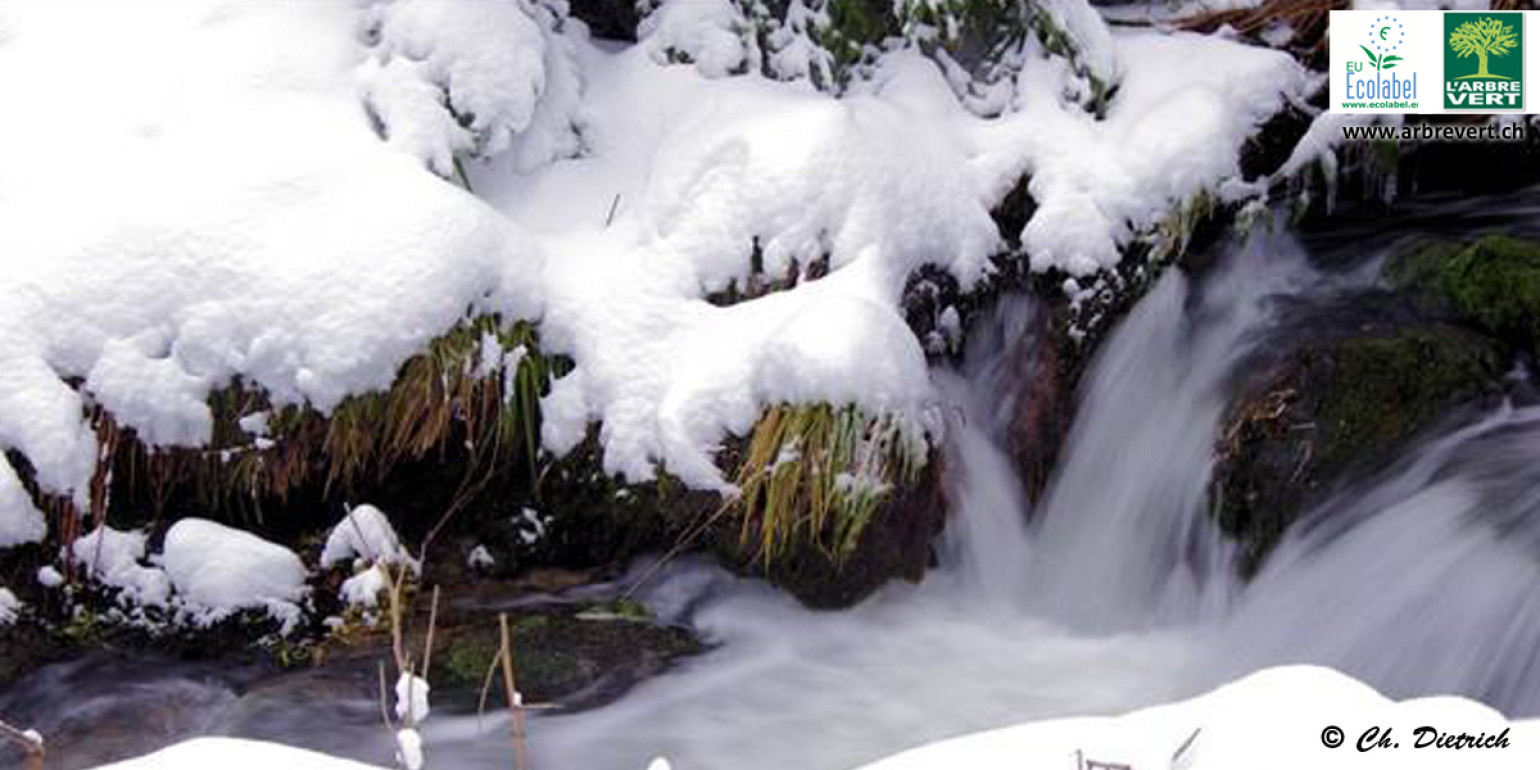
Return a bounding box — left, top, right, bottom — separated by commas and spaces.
1384, 236, 1540, 351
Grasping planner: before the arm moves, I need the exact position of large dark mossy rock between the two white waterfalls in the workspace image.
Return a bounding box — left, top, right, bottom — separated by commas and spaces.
1210, 322, 1506, 576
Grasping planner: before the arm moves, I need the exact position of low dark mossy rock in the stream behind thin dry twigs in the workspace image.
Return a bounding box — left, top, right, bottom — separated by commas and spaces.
431, 601, 704, 708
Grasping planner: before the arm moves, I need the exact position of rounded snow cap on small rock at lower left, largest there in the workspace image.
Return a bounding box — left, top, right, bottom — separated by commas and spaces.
160, 519, 306, 633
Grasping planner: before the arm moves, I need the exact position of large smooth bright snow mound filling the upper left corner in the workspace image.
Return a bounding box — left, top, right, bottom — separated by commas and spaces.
0, 0, 539, 501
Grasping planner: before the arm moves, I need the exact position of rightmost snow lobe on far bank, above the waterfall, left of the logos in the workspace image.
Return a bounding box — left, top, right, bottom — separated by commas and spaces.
984, 32, 1312, 276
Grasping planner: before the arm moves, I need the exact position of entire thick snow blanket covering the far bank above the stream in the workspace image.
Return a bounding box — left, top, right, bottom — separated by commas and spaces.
0, 0, 1312, 505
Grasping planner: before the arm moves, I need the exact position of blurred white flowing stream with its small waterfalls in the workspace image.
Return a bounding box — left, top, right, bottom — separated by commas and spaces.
3, 206, 1540, 770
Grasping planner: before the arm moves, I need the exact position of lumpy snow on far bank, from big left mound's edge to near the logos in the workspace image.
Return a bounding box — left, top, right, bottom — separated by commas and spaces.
473, 31, 1307, 487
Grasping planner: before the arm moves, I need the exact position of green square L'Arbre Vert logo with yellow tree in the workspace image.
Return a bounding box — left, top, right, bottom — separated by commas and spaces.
1445, 12, 1525, 112
